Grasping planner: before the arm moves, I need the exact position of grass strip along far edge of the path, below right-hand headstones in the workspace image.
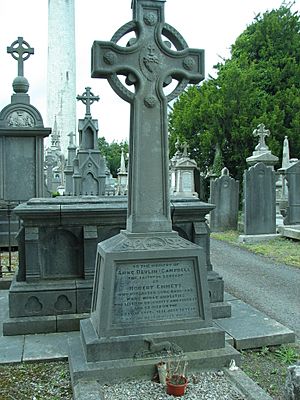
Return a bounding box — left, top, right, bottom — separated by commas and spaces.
211, 231, 300, 268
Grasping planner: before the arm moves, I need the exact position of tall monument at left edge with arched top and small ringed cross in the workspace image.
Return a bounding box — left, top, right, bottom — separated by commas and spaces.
0, 37, 51, 246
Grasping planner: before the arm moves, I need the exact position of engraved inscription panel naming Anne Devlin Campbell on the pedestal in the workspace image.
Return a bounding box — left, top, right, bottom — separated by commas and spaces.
113, 260, 200, 324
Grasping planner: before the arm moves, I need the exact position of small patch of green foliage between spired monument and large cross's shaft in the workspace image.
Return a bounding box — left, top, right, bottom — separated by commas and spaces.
98, 137, 128, 178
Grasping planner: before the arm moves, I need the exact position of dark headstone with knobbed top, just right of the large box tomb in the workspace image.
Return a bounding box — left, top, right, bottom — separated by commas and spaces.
210, 168, 239, 232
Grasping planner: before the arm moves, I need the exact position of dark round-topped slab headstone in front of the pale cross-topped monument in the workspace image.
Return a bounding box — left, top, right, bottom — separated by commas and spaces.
244, 163, 276, 235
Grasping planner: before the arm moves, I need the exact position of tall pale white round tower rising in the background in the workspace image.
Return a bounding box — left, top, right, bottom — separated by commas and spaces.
47, 0, 76, 157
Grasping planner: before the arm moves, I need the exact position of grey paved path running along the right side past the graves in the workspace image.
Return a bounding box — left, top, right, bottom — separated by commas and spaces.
211, 239, 300, 339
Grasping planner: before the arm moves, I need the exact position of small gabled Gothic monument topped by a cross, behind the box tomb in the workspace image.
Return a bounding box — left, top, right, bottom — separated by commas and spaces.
73, 87, 106, 196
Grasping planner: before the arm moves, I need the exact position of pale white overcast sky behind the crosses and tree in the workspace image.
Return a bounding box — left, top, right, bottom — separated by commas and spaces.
0, 0, 300, 141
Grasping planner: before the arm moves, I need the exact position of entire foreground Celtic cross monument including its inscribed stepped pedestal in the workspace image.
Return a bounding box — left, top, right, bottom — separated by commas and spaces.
69, 0, 239, 385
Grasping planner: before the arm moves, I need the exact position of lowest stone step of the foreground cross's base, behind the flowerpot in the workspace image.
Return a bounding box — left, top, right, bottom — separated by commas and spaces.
69, 338, 240, 387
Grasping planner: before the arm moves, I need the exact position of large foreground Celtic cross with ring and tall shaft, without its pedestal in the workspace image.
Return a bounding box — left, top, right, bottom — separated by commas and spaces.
92, 0, 204, 233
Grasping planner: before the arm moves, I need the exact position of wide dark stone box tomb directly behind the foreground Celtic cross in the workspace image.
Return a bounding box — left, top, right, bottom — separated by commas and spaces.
5, 196, 230, 334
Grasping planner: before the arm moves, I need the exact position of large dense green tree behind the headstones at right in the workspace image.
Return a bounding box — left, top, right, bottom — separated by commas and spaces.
169, 4, 300, 179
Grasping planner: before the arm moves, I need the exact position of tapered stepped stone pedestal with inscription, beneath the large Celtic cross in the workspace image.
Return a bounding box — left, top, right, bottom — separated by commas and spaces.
70, 231, 235, 385
